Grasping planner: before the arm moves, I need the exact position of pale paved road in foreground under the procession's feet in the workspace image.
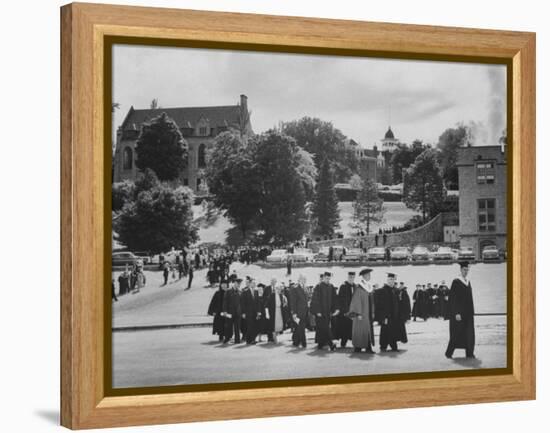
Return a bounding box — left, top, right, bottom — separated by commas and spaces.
113, 316, 506, 388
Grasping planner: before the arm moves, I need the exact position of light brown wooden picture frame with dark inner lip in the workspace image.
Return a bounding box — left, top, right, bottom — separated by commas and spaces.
61, 3, 535, 429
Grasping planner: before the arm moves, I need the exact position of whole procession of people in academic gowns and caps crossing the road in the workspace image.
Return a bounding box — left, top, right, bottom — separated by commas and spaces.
208, 261, 475, 358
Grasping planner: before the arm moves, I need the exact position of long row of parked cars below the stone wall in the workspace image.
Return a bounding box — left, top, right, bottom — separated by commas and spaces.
267, 245, 505, 263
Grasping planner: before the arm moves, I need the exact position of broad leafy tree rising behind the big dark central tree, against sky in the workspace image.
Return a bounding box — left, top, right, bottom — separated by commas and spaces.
282, 117, 358, 182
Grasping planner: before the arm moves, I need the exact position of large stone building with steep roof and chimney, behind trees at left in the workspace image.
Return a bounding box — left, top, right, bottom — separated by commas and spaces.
113, 95, 253, 195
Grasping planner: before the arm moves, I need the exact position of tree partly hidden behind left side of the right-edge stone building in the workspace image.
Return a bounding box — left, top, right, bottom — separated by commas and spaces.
437, 123, 468, 189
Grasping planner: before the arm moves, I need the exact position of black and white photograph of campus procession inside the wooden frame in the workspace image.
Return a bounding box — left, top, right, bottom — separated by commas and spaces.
110, 44, 509, 389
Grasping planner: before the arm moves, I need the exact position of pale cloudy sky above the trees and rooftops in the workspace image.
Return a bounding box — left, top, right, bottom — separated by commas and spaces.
113, 45, 506, 148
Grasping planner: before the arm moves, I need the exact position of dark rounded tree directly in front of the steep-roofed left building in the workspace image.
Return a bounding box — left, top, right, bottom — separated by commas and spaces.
136, 113, 187, 181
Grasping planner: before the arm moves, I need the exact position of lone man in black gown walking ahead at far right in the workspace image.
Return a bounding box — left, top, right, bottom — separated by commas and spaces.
445, 262, 475, 358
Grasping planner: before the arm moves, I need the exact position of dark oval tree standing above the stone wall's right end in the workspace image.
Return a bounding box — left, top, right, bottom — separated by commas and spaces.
405, 149, 445, 221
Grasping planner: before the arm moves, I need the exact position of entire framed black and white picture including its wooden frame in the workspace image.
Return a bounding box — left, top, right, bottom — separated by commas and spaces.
61, 4, 535, 429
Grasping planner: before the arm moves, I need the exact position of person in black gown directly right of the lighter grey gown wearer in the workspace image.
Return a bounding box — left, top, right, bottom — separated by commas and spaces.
375, 273, 402, 352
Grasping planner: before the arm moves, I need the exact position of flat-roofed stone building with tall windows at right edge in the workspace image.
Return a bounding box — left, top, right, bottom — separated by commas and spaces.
457, 146, 507, 258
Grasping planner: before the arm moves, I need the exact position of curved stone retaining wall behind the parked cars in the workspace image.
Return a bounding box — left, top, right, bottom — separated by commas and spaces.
309, 214, 443, 252
